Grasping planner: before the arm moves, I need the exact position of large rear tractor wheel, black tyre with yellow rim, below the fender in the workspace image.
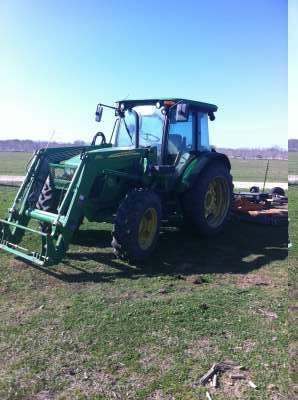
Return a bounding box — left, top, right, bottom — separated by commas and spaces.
182, 163, 233, 235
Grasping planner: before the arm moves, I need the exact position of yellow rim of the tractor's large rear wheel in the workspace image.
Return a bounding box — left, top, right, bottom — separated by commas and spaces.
204, 177, 230, 228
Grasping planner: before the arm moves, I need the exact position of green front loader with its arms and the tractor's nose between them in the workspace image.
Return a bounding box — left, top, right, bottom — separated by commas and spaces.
0, 144, 151, 266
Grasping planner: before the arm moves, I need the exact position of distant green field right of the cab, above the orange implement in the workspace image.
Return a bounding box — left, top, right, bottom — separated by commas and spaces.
230, 159, 288, 182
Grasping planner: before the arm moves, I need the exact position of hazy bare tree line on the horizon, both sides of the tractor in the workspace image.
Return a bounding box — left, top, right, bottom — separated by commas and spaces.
0, 139, 288, 160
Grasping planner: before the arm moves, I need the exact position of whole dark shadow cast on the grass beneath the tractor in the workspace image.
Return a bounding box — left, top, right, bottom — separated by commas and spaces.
35, 220, 288, 283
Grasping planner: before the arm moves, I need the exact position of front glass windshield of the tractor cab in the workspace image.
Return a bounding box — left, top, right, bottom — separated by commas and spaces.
115, 106, 164, 155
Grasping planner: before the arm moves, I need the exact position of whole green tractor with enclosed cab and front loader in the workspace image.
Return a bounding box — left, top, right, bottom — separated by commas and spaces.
0, 98, 233, 266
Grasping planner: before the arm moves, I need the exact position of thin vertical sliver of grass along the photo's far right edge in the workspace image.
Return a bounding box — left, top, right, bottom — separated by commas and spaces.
289, 185, 298, 398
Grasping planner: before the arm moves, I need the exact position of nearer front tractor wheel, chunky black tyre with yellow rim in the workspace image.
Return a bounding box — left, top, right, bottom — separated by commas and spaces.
112, 189, 161, 261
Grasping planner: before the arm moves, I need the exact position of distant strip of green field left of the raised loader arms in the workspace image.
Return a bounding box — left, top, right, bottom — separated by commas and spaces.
0, 151, 32, 175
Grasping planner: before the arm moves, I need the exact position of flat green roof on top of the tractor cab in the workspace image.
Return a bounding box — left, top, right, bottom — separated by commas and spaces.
116, 97, 217, 113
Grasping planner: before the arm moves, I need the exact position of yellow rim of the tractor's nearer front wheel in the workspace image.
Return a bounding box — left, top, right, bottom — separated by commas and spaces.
138, 208, 157, 250
